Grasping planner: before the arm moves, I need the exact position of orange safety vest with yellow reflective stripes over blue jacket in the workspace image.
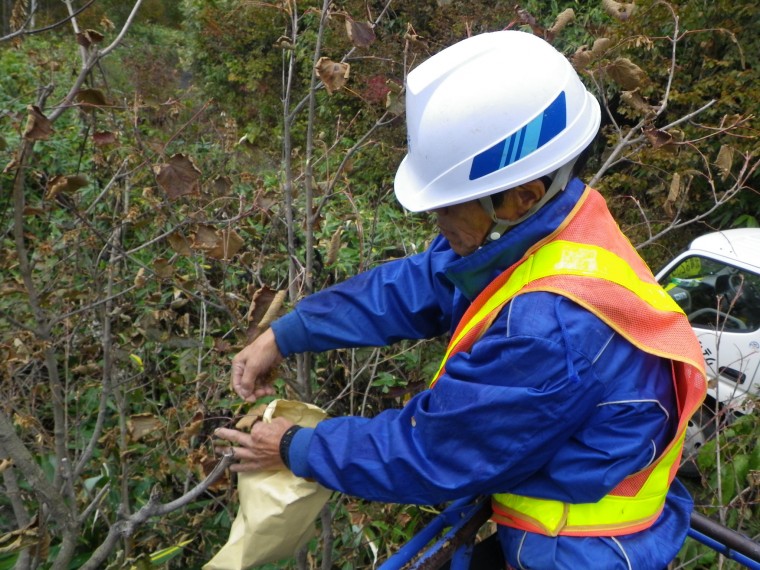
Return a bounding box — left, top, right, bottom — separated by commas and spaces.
430, 187, 707, 536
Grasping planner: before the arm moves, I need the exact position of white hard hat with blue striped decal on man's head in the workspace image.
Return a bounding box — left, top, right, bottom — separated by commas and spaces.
395, 31, 600, 212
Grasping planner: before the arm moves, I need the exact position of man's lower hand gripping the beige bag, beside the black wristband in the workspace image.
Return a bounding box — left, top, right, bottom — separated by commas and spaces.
214, 412, 293, 472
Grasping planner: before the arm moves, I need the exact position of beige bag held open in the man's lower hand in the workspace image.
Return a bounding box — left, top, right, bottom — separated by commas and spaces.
203, 400, 331, 570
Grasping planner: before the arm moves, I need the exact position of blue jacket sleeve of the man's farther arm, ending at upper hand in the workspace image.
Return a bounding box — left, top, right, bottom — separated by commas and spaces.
272, 233, 458, 356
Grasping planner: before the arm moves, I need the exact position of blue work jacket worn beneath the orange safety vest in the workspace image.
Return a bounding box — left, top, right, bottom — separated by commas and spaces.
272, 179, 692, 570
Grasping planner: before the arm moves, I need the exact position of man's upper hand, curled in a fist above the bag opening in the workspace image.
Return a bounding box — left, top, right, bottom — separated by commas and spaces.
232, 329, 282, 402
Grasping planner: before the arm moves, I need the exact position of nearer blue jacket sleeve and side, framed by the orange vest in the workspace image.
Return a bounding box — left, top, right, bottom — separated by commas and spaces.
290, 294, 667, 504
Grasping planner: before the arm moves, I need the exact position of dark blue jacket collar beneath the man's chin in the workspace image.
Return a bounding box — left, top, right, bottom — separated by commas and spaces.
445, 178, 586, 301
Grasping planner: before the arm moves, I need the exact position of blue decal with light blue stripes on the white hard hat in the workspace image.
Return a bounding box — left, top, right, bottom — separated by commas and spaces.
470, 91, 567, 180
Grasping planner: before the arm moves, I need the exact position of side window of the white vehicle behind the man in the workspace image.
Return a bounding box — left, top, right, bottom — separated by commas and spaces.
660, 256, 760, 332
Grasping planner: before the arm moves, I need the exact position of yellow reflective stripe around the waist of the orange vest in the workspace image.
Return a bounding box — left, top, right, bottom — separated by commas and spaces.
493, 432, 685, 536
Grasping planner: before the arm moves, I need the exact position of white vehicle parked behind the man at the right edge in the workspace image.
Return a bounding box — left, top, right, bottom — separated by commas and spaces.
657, 228, 760, 474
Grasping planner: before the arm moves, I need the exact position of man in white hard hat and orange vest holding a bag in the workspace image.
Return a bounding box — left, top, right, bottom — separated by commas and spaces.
218, 31, 705, 570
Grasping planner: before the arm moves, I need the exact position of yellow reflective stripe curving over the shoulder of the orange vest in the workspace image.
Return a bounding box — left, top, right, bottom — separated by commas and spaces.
434, 240, 683, 380
